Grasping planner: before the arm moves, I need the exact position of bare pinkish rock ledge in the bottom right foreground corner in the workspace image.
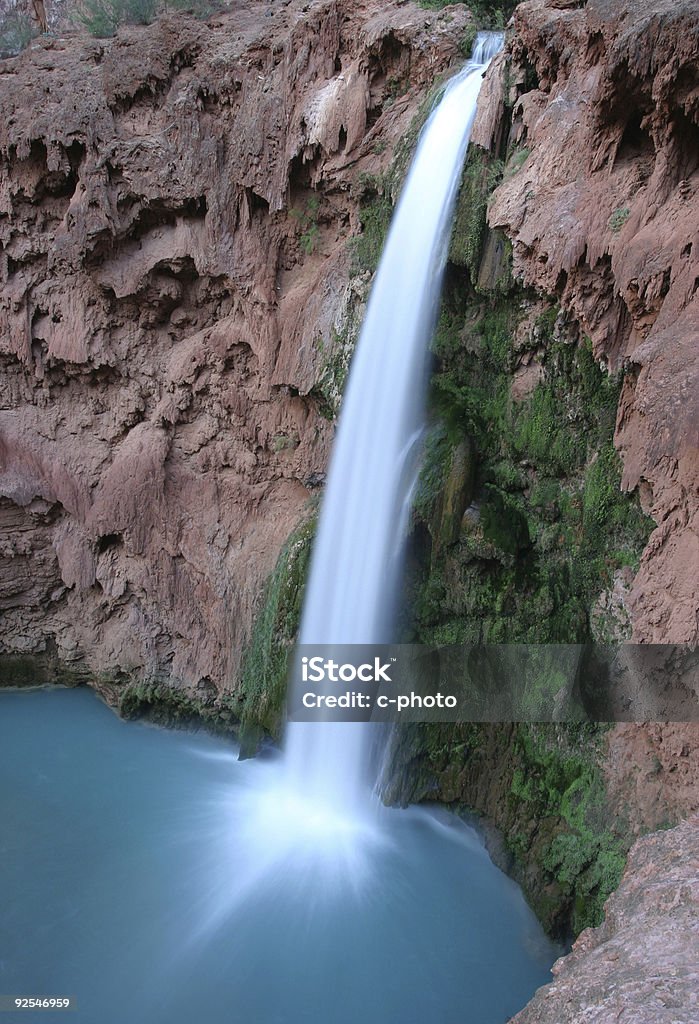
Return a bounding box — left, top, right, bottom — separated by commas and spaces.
513, 817, 699, 1024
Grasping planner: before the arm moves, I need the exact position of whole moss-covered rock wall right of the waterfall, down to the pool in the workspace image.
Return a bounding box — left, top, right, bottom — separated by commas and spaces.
387, 132, 653, 936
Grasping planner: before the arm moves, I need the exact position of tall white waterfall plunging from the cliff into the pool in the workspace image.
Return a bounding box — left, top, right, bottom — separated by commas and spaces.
286, 33, 503, 816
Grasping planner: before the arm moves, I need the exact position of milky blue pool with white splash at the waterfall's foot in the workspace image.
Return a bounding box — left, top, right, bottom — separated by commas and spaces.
0, 689, 556, 1024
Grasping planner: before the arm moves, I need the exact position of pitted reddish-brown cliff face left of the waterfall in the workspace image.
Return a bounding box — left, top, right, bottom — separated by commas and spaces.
0, 0, 469, 693
